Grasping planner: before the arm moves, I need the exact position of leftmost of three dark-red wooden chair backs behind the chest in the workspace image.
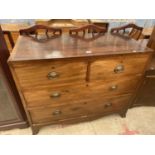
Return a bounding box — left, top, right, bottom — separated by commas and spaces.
19, 25, 62, 41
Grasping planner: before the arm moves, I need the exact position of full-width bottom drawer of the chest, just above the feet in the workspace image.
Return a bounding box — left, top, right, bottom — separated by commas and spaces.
29, 96, 130, 123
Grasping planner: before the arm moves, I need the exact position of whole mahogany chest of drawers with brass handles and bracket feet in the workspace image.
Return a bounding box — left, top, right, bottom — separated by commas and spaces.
8, 33, 152, 134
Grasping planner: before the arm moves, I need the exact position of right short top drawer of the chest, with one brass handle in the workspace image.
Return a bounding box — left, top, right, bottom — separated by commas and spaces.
90, 54, 149, 81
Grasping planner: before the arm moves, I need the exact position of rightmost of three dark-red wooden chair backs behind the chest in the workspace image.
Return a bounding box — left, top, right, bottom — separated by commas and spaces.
111, 23, 143, 40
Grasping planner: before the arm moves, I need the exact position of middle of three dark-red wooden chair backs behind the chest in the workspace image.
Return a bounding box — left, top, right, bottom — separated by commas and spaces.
69, 24, 106, 40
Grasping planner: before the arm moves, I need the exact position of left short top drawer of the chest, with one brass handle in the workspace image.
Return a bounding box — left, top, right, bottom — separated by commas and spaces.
14, 61, 87, 90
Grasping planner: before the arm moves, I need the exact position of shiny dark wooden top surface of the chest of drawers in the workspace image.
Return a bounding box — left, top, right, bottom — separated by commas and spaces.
9, 33, 153, 61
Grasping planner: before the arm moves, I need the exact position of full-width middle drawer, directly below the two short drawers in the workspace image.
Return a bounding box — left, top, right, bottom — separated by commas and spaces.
24, 76, 141, 107
